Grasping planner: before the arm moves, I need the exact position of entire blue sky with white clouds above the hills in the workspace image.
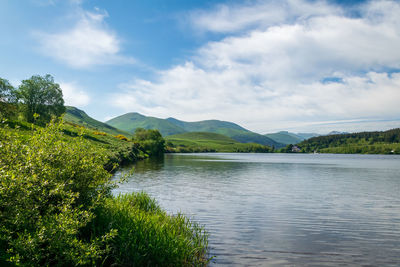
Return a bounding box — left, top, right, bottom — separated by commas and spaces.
0, 0, 400, 133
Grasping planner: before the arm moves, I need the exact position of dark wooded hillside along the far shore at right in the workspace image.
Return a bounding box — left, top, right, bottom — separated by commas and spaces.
297, 128, 400, 154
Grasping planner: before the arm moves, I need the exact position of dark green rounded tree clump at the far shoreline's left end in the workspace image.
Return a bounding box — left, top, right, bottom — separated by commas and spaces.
133, 128, 165, 156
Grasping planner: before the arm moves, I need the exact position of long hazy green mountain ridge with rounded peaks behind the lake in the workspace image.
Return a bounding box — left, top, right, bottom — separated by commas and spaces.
106, 113, 284, 148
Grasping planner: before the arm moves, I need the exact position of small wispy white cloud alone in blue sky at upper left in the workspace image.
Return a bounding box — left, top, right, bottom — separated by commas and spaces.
35, 8, 134, 68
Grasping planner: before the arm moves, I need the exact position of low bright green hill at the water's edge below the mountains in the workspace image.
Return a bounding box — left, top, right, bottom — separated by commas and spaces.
165, 132, 272, 152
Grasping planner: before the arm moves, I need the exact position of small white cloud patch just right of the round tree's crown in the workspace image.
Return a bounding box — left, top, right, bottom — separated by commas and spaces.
60, 82, 90, 108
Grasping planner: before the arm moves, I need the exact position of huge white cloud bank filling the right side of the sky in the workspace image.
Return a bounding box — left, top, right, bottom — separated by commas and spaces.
110, 0, 400, 132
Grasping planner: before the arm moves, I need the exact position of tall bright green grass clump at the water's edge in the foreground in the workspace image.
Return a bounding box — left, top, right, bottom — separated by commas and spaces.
90, 193, 208, 266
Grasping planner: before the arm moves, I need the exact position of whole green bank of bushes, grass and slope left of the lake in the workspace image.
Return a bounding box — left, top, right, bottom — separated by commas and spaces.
0, 121, 211, 266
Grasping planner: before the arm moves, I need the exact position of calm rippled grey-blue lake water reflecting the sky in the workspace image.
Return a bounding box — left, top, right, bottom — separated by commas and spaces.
112, 154, 400, 266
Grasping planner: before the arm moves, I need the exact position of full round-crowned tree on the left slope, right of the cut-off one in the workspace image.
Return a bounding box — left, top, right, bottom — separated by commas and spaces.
17, 74, 65, 122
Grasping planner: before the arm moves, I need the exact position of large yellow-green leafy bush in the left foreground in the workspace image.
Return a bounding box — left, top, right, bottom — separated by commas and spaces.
0, 121, 115, 266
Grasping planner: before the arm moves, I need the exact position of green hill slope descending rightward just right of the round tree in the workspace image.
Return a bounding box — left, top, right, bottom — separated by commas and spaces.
64, 106, 131, 136
